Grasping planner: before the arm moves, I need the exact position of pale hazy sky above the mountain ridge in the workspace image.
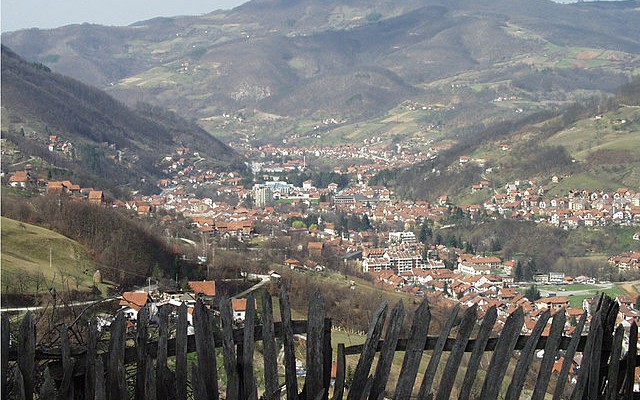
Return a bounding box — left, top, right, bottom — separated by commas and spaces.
0, 0, 246, 32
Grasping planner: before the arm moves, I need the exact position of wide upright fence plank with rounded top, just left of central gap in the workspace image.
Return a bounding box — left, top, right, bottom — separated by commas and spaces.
303, 292, 325, 399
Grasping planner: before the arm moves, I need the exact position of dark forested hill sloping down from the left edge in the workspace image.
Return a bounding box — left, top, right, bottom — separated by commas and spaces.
2, 46, 240, 195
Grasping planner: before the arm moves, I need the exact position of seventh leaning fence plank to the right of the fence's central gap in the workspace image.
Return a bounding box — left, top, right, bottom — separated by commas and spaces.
480, 307, 524, 399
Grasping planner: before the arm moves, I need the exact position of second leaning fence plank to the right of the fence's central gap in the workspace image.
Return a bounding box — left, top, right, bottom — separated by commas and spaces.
369, 300, 406, 399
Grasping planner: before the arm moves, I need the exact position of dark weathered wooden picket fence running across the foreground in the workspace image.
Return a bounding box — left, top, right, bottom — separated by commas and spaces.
1, 289, 638, 400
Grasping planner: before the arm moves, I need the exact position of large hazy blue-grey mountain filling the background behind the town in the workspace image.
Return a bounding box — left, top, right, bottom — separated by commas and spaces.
2, 0, 640, 129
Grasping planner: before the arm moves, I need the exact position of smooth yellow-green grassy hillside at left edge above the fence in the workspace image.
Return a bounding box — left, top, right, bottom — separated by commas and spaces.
1, 217, 97, 295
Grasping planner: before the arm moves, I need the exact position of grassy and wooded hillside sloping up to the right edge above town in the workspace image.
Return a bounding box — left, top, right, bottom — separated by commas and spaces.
370, 81, 640, 203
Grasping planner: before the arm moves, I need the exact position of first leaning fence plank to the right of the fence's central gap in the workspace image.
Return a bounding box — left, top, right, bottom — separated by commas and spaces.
347, 301, 389, 400
